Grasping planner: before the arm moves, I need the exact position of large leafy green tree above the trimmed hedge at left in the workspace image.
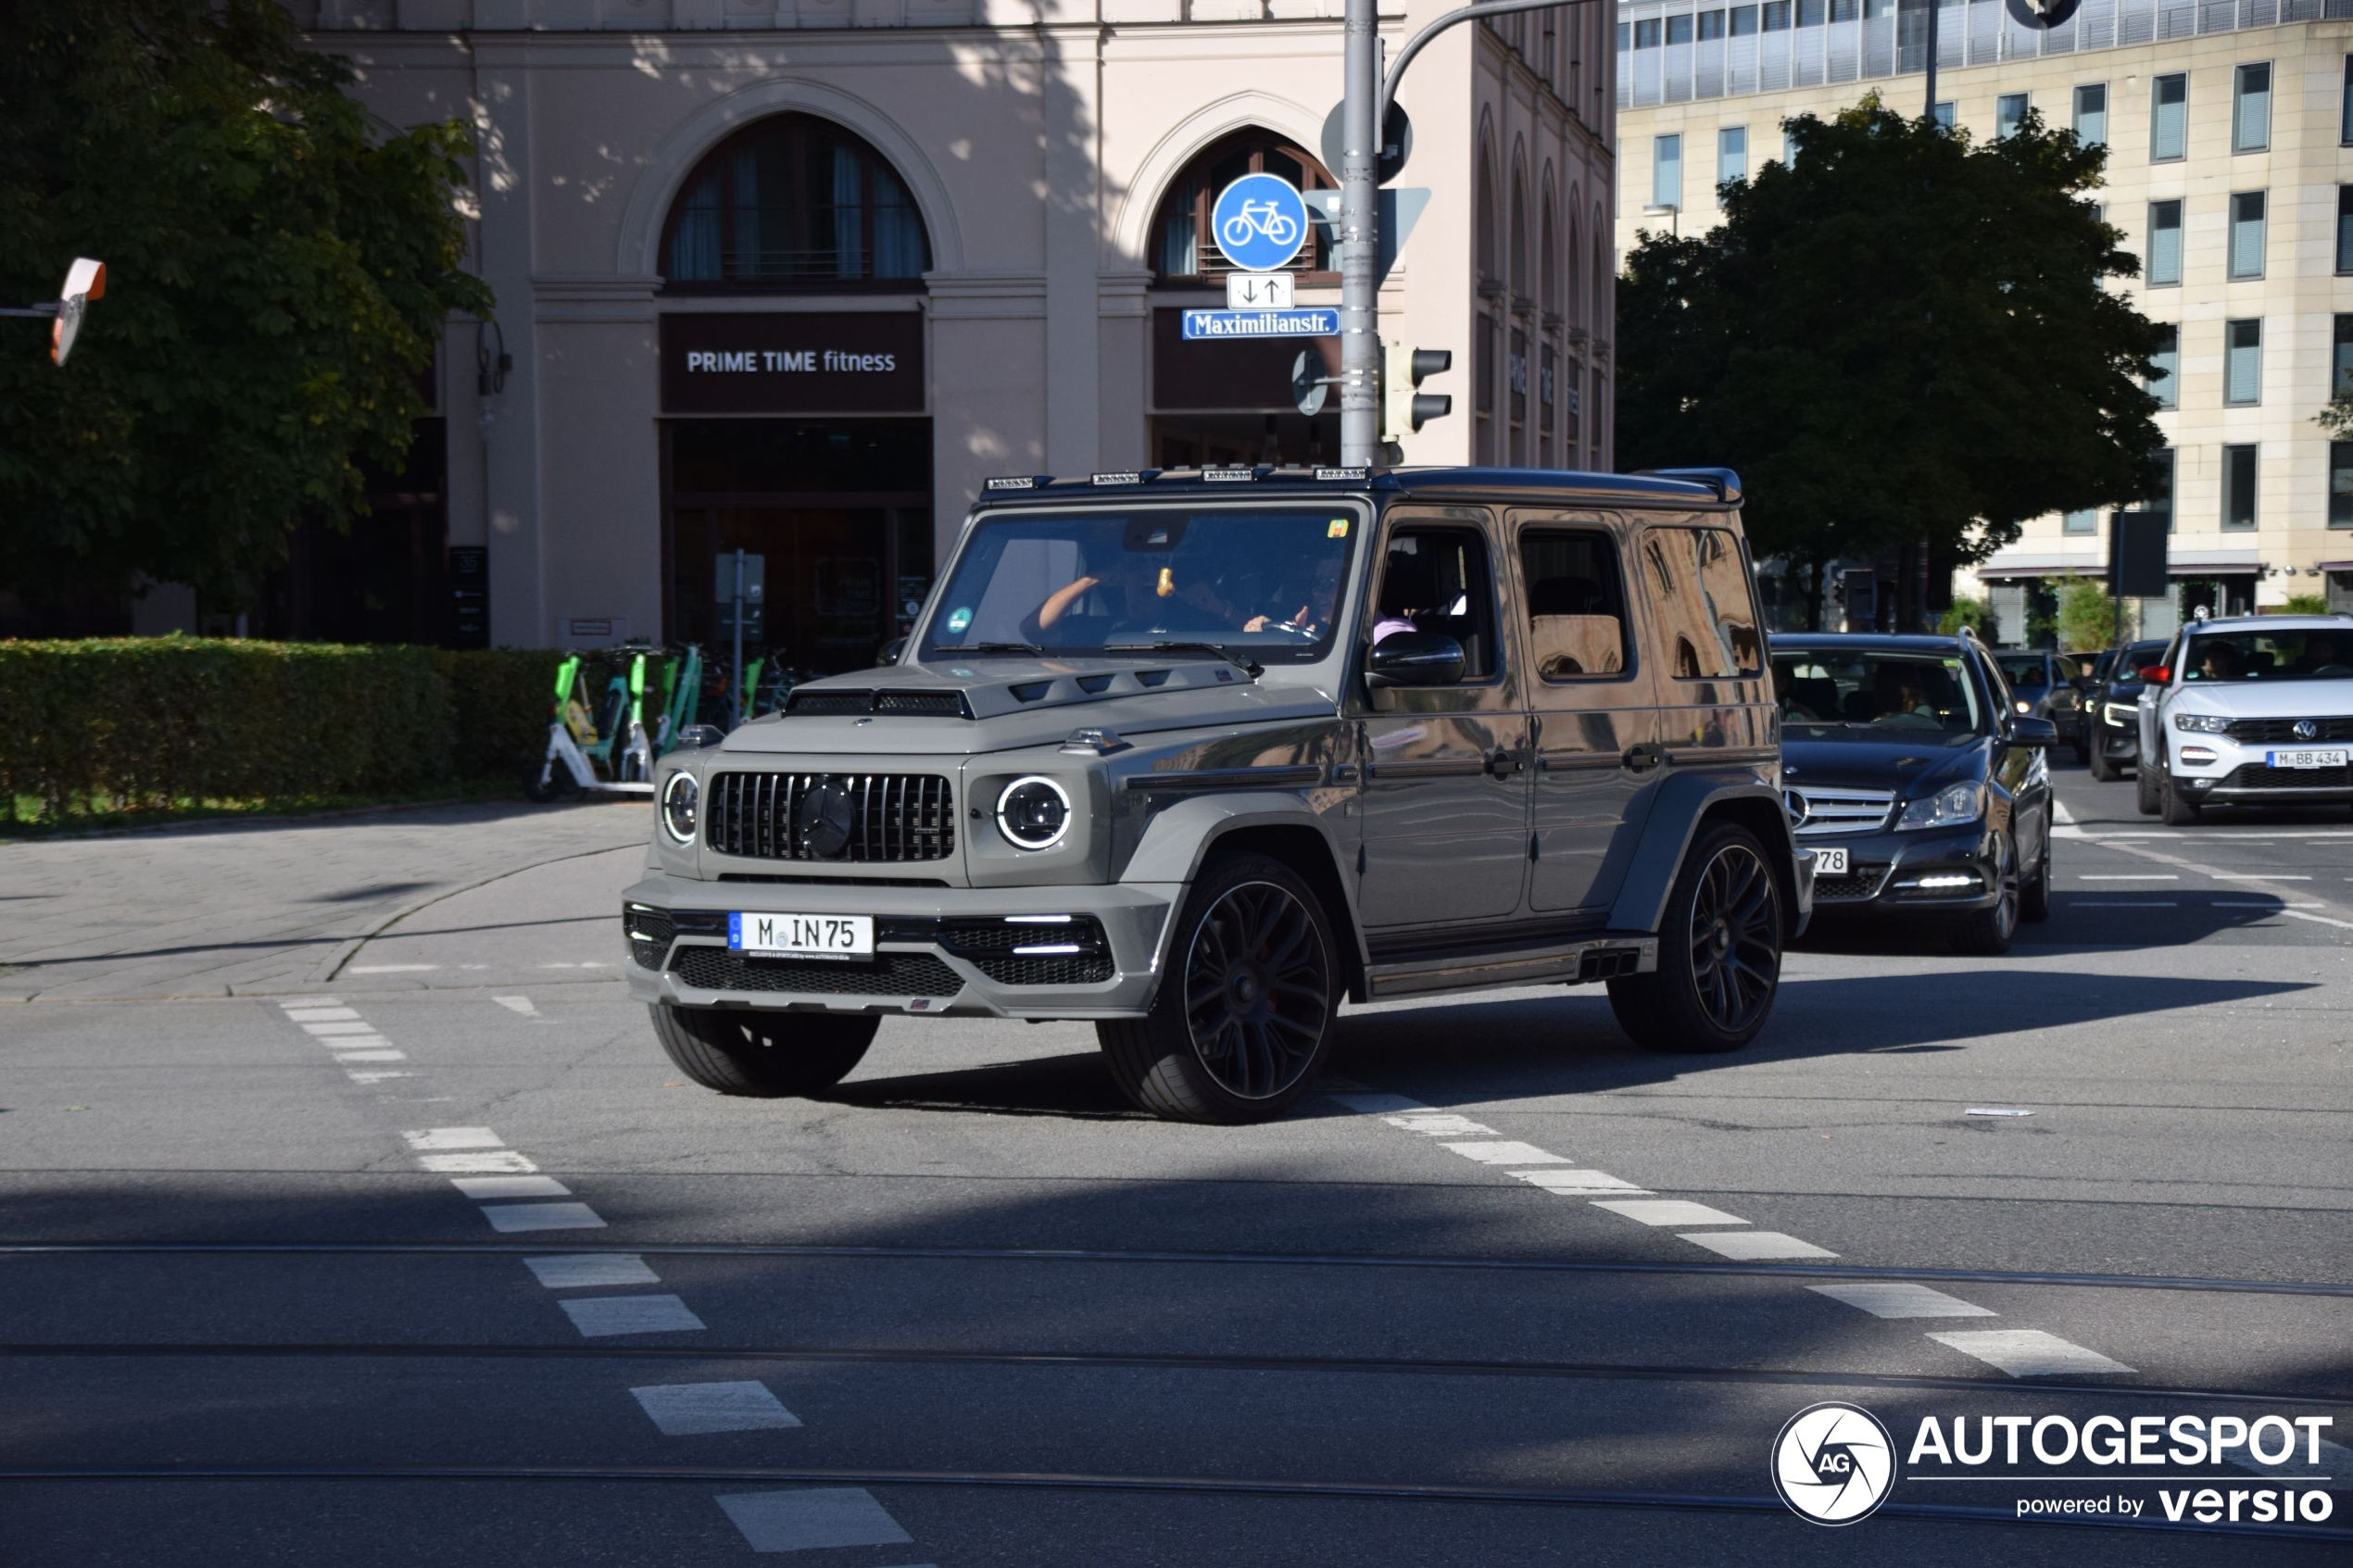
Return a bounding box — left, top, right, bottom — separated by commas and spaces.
0, 0, 489, 597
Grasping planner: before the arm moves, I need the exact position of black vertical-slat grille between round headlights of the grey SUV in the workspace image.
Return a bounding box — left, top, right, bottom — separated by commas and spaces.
703, 773, 955, 863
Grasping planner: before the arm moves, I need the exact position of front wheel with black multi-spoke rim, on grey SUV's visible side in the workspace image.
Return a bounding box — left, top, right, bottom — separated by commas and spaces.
1094, 853, 1343, 1126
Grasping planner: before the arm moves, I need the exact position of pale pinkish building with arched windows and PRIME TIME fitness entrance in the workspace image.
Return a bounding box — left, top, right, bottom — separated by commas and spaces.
289, 0, 1617, 670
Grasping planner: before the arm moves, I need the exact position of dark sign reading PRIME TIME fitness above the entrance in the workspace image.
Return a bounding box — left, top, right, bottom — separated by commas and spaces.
661, 310, 925, 414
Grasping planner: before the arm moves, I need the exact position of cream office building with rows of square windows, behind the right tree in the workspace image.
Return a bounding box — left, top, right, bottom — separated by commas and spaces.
1617, 0, 2353, 639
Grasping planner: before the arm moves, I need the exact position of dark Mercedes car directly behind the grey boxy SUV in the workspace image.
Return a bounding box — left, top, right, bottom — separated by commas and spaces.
1772, 633, 2057, 955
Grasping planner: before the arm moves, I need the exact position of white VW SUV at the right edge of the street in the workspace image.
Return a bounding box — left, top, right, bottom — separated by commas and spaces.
2139, 616, 2353, 827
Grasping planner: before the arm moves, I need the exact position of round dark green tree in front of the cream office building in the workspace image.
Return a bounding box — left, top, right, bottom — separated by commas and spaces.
1617, 94, 2165, 611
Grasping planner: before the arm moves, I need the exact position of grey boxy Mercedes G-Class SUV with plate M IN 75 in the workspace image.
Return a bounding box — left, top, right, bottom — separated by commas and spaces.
623, 468, 1812, 1122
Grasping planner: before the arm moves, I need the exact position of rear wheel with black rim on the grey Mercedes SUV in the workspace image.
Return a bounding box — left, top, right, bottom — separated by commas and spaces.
1609, 822, 1783, 1053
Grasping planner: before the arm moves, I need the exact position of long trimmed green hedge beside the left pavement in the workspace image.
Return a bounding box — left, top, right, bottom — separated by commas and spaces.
0, 637, 562, 822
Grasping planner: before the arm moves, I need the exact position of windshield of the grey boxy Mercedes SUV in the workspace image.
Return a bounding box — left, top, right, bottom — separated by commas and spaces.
925, 503, 1363, 663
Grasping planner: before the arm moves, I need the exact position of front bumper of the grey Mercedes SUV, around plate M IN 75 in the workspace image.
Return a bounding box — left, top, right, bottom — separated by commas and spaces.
622, 872, 1184, 1018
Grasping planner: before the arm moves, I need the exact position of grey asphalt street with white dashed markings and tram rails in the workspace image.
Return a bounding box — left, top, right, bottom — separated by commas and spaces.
0, 766, 2353, 1568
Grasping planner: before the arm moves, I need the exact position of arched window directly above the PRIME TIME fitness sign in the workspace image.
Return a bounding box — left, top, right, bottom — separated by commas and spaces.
661, 115, 932, 292
